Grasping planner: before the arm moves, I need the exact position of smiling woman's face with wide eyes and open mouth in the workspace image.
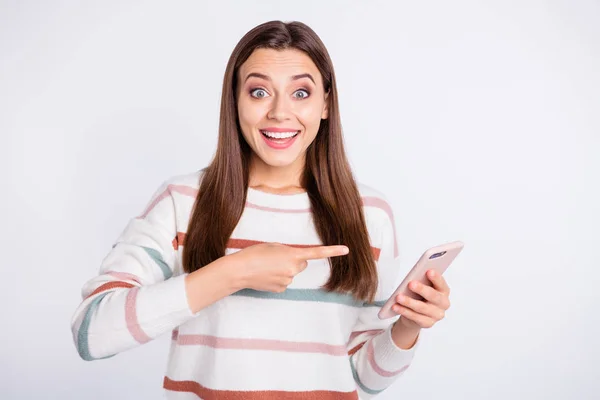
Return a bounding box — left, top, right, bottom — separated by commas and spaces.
237, 49, 328, 169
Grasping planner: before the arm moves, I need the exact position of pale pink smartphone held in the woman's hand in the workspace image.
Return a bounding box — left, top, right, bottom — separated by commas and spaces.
378, 241, 464, 319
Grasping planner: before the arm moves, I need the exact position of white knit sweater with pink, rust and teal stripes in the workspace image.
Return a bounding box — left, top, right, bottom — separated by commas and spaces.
71, 172, 418, 400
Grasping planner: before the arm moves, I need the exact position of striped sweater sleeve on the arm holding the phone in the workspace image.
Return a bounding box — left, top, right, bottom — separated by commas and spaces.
348, 203, 420, 399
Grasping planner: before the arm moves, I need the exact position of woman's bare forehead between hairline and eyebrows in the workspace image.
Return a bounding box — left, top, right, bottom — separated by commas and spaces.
239, 49, 321, 83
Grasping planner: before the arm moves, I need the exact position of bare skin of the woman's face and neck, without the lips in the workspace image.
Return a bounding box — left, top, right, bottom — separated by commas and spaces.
237, 49, 329, 193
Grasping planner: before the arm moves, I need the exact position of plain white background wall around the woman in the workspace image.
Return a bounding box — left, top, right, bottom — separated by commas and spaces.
0, 0, 600, 400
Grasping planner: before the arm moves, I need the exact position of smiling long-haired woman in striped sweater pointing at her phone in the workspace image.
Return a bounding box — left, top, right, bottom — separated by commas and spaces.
72, 21, 449, 399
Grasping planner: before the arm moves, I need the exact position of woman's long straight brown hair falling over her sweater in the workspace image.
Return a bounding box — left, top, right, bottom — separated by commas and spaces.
183, 21, 377, 301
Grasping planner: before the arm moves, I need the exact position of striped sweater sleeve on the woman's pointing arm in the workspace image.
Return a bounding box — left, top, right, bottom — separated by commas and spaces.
71, 182, 193, 361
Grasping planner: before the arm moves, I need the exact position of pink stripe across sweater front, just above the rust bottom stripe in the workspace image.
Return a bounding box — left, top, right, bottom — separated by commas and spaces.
177, 335, 348, 356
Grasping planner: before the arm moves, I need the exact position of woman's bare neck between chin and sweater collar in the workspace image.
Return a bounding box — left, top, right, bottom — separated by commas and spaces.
248, 153, 304, 194
